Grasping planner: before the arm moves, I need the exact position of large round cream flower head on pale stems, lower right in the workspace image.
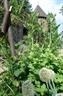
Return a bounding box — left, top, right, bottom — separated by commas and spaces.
39, 68, 55, 82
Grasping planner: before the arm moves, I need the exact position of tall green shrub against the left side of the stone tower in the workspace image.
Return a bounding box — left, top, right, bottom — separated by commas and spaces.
25, 13, 44, 45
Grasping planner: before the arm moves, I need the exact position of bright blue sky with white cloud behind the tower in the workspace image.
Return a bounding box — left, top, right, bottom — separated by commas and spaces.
29, 0, 63, 32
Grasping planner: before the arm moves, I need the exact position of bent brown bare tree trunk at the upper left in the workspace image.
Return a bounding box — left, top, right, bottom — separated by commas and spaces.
2, 0, 15, 56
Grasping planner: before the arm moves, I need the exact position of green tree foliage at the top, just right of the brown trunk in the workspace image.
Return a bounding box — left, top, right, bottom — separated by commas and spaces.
10, 0, 31, 22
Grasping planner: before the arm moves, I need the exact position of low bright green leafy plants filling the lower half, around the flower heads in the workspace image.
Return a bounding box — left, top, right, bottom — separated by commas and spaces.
0, 44, 63, 96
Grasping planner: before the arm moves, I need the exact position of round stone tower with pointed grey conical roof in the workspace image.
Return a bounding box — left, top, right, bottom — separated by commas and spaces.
34, 5, 48, 32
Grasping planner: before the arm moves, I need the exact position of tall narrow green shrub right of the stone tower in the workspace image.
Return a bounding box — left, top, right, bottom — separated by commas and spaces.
47, 13, 61, 51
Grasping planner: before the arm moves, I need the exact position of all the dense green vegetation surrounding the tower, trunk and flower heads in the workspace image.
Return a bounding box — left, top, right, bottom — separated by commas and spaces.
0, 0, 63, 96
